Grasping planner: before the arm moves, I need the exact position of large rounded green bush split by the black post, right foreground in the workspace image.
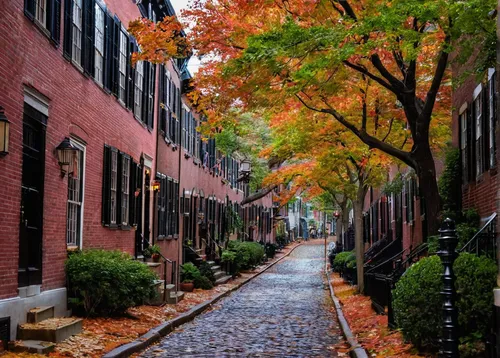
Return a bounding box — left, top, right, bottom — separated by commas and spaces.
392, 253, 497, 349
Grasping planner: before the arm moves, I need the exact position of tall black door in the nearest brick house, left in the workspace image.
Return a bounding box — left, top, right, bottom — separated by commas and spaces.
19, 104, 47, 287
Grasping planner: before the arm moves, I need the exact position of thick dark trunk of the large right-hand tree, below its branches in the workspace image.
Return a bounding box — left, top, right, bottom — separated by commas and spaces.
414, 145, 441, 236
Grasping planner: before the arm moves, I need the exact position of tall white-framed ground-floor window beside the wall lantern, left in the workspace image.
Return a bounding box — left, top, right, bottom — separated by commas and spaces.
66, 140, 85, 247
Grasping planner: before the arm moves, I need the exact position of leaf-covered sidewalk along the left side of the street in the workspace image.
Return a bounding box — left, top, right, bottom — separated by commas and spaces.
0, 243, 298, 358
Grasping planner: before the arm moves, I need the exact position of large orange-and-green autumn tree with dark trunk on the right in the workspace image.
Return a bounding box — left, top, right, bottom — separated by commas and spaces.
177, 0, 495, 232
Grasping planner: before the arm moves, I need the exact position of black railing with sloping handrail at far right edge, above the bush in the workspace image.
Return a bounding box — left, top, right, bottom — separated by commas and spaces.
458, 213, 497, 260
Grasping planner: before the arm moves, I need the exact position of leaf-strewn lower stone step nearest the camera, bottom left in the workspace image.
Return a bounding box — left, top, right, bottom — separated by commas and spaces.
17, 317, 83, 343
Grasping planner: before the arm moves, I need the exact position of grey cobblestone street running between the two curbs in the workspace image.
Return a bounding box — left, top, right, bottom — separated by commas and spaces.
142, 240, 342, 357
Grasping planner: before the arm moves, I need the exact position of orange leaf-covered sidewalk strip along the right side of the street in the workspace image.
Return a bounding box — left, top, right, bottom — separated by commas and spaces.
330, 273, 424, 358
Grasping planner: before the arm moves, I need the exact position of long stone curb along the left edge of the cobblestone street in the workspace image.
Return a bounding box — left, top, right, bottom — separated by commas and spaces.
103, 243, 302, 358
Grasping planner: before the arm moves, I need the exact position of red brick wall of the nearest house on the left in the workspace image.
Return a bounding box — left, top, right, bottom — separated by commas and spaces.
0, 0, 156, 298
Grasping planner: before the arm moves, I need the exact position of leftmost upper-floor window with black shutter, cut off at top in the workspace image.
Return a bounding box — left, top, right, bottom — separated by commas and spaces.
24, 0, 61, 46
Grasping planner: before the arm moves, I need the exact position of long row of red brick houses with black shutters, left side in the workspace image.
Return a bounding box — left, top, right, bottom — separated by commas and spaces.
0, 0, 274, 340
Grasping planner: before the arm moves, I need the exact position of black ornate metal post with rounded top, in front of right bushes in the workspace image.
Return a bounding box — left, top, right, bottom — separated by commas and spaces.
437, 218, 459, 358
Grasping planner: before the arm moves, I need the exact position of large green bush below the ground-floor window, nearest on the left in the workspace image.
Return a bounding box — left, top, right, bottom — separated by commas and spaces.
66, 250, 157, 316
